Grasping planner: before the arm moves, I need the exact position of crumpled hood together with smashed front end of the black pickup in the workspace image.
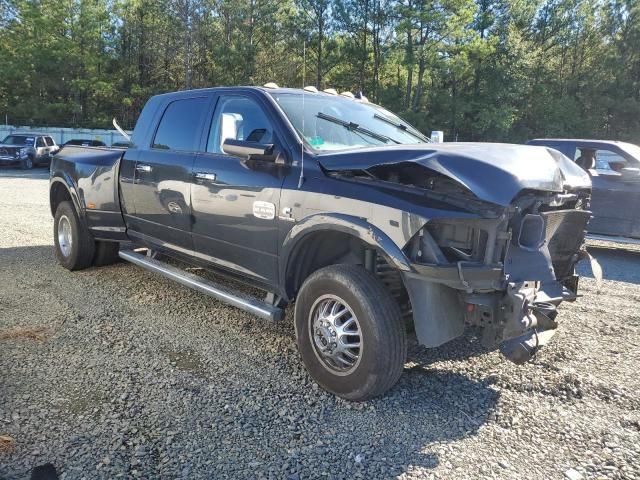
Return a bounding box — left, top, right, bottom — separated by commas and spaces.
321, 144, 595, 363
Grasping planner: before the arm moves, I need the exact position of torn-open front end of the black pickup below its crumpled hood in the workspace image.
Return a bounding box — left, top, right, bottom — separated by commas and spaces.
404, 190, 591, 363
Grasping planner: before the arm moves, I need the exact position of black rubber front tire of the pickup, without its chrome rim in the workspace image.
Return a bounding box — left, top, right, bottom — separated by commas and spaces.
295, 265, 407, 401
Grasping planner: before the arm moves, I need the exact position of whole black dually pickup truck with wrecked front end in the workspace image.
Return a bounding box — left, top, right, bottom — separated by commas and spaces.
50, 86, 591, 400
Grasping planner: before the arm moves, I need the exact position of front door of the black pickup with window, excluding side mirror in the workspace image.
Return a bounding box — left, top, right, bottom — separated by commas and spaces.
191, 93, 287, 284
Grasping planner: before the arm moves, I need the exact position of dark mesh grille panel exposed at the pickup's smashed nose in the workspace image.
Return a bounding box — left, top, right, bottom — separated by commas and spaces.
540, 210, 591, 279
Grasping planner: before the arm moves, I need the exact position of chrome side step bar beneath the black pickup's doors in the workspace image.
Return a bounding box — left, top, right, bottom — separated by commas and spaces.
119, 250, 284, 320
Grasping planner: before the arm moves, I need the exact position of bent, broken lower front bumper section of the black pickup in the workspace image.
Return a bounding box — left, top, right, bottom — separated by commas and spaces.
403, 263, 577, 363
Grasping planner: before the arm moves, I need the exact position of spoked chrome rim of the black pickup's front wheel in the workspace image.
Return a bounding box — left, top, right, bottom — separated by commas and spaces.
309, 295, 362, 376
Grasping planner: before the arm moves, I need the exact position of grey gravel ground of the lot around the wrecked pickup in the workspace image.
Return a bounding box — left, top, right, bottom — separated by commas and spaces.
0, 169, 640, 479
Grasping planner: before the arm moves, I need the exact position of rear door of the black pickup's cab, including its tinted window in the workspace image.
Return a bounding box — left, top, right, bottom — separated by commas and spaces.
125, 94, 211, 254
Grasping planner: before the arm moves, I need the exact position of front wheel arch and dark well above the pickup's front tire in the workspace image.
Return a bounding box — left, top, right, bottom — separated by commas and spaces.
286, 231, 411, 314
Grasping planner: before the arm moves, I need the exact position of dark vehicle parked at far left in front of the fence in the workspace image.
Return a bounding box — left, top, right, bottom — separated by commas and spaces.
0, 133, 60, 169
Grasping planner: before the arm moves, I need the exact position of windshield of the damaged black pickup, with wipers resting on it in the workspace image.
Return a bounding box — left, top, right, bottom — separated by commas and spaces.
271, 93, 429, 152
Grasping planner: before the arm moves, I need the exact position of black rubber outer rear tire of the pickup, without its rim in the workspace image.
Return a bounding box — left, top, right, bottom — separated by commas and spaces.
53, 201, 95, 270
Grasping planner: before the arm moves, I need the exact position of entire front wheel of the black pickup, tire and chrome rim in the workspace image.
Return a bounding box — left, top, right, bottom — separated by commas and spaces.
295, 265, 407, 401
